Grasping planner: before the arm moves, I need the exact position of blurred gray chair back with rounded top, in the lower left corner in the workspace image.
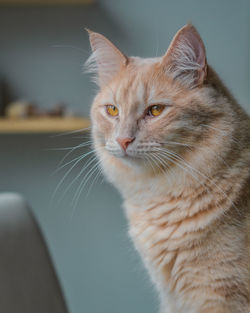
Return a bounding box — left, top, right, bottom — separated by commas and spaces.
0, 193, 67, 313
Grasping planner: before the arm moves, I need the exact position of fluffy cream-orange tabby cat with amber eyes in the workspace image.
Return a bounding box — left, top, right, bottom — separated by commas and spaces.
86, 24, 250, 313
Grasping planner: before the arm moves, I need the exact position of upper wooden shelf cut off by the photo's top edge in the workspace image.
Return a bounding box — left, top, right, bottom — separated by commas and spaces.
0, 0, 95, 6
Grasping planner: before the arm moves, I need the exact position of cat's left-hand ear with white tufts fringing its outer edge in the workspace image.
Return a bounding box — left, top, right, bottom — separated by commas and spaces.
85, 29, 128, 87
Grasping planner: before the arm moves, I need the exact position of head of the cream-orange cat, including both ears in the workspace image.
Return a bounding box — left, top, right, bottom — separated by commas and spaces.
87, 24, 229, 179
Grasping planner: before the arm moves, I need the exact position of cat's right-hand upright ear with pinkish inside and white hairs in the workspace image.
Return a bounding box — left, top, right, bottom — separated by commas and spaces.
162, 24, 207, 88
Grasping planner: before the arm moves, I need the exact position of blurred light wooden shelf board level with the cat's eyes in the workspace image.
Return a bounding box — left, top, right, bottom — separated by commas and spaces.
0, 117, 90, 134
